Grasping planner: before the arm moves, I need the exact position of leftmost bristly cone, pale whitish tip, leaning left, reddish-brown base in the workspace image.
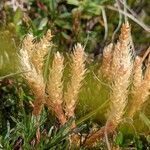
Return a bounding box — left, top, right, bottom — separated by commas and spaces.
20, 48, 45, 116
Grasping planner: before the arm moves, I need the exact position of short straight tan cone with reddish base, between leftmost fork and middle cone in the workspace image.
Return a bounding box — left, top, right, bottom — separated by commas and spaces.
46, 52, 66, 124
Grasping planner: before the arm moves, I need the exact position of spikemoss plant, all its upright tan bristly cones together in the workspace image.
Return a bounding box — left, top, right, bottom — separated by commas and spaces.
20, 22, 150, 147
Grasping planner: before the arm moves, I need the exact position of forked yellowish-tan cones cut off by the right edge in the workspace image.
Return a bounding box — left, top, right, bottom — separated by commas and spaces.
128, 48, 150, 118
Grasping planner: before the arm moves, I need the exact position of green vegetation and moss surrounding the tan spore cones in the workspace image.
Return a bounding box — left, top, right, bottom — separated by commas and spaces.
0, 0, 150, 150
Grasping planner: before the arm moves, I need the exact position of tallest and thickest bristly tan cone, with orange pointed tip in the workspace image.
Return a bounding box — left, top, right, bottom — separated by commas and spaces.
107, 23, 133, 127
